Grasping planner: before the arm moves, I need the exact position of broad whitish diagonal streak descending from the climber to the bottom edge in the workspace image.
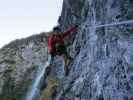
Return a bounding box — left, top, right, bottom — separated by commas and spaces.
25, 62, 49, 100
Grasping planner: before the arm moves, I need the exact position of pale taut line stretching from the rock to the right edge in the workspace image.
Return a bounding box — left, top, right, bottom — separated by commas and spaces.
95, 20, 133, 28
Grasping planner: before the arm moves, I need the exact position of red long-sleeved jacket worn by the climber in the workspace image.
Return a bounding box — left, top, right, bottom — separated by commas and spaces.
48, 27, 77, 52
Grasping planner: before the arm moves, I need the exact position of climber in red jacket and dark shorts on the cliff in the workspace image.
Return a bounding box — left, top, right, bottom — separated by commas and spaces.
48, 25, 78, 75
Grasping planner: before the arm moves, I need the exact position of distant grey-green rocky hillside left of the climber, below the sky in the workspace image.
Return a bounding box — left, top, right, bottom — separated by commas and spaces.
0, 33, 47, 100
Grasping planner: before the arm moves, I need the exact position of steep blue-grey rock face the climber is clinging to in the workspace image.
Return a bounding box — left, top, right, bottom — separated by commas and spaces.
50, 0, 133, 100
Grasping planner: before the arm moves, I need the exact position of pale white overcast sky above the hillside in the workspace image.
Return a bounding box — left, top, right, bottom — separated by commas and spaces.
0, 0, 63, 47
